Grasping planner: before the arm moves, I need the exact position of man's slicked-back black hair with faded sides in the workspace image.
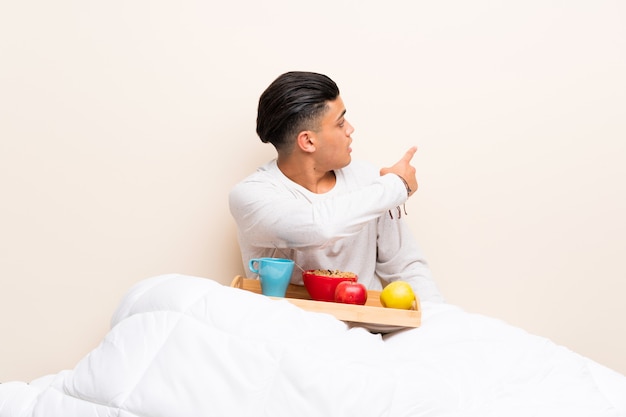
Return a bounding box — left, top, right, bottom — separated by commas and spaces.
256, 71, 339, 150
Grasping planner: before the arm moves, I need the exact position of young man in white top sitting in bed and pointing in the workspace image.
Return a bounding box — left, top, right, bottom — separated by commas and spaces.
229, 72, 442, 301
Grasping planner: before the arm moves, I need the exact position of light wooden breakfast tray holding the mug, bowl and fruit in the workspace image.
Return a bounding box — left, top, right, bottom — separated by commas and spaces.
230, 275, 422, 333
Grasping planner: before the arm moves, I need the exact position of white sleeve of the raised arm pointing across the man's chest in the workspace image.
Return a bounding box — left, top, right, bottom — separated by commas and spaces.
229, 167, 407, 249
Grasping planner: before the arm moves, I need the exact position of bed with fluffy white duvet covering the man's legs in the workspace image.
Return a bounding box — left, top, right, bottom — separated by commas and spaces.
0, 274, 626, 417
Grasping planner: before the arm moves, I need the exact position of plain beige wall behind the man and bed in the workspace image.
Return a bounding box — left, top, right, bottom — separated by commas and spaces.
0, 0, 626, 381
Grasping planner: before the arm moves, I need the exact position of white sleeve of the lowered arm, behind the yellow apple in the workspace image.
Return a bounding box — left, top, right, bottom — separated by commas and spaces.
376, 215, 444, 302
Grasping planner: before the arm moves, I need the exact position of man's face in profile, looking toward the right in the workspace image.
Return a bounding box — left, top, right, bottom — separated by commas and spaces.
315, 97, 354, 171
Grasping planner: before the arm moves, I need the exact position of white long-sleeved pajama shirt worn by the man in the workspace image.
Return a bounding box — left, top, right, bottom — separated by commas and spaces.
229, 160, 443, 301
